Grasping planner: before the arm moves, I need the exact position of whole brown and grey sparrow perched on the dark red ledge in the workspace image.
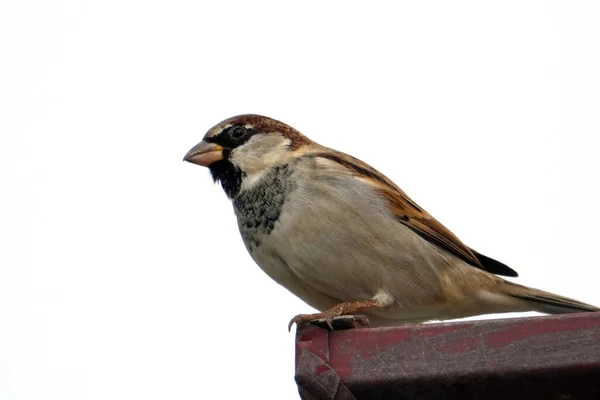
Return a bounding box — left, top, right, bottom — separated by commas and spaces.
184, 115, 600, 327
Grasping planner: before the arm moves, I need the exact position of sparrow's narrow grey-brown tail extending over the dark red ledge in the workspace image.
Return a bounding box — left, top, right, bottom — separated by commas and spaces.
502, 281, 600, 314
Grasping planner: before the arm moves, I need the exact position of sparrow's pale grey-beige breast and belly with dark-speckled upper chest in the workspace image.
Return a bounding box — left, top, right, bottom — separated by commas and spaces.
234, 159, 450, 303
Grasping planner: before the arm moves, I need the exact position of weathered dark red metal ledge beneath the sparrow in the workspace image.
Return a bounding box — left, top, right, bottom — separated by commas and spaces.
296, 313, 600, 400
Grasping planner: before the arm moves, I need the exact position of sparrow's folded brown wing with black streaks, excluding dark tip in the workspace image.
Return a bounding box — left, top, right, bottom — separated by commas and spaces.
315, 152, 484, 269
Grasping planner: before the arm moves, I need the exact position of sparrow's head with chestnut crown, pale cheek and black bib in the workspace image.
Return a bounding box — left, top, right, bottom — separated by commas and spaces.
183, 114, 313, 198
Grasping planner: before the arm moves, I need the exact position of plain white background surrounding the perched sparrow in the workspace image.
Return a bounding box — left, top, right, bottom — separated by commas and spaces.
0, 0, 600, 400
